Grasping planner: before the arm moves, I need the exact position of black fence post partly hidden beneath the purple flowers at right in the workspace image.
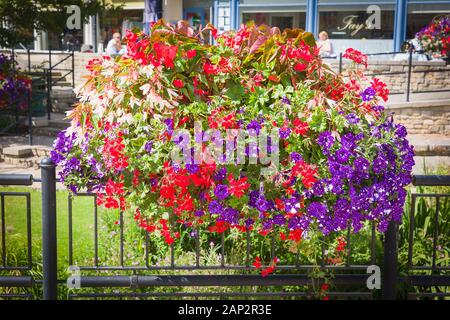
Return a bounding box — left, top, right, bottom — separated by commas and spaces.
382, 221, 398, 300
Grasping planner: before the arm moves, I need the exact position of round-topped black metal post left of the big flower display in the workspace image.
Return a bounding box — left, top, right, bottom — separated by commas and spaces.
40, 158, 58, 300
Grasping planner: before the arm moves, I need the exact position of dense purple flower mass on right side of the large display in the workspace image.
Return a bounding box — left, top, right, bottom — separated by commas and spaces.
300, 117, 414, 234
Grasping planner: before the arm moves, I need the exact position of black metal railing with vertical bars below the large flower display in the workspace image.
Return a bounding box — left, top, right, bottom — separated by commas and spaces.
0, 159, 450, 299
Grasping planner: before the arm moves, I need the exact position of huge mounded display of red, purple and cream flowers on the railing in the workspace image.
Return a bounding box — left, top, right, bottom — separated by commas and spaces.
52, 21, 414, 274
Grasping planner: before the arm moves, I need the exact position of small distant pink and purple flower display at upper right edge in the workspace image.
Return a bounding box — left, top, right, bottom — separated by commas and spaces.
416, 15, 450, 57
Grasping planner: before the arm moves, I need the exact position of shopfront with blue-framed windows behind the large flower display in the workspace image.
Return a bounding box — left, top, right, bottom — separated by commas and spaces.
35, 0, 450, 53
